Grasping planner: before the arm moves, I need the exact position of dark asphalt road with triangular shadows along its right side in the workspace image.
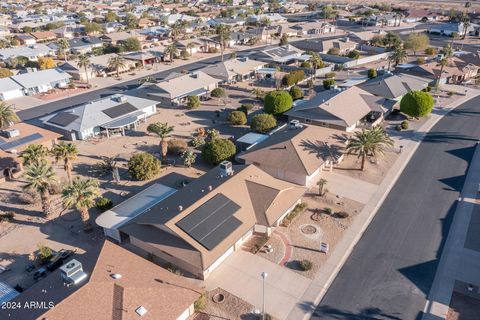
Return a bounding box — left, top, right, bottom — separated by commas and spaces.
312, 97, 480, 320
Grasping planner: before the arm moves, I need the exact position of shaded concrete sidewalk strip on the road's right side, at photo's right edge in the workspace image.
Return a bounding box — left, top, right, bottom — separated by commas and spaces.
423, 144, 480, 320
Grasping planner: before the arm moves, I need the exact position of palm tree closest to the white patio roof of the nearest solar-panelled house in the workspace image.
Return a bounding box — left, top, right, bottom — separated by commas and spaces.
62, 177, 100, 230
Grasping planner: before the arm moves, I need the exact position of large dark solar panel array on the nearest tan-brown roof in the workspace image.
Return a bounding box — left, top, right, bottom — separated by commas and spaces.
176, 193, 242, 250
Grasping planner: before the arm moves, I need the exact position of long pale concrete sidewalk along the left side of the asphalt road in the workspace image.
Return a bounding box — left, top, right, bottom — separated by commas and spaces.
287, 89, 480, 320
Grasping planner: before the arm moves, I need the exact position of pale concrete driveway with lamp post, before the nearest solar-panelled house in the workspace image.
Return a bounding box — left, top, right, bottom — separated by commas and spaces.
205, 250, 311, 320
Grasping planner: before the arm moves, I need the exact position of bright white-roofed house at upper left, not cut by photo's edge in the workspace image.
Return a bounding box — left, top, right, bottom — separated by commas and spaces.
10, 68, 71, 95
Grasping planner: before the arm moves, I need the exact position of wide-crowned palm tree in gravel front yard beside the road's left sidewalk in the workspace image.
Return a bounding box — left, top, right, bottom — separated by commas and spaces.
346, 126, 393, 171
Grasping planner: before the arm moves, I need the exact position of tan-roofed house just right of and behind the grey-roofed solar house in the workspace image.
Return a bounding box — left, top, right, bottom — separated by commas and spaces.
136, 70, 220, 106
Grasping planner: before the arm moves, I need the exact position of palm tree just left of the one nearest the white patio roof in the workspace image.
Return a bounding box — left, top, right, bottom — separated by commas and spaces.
22, 161, 56, 216
